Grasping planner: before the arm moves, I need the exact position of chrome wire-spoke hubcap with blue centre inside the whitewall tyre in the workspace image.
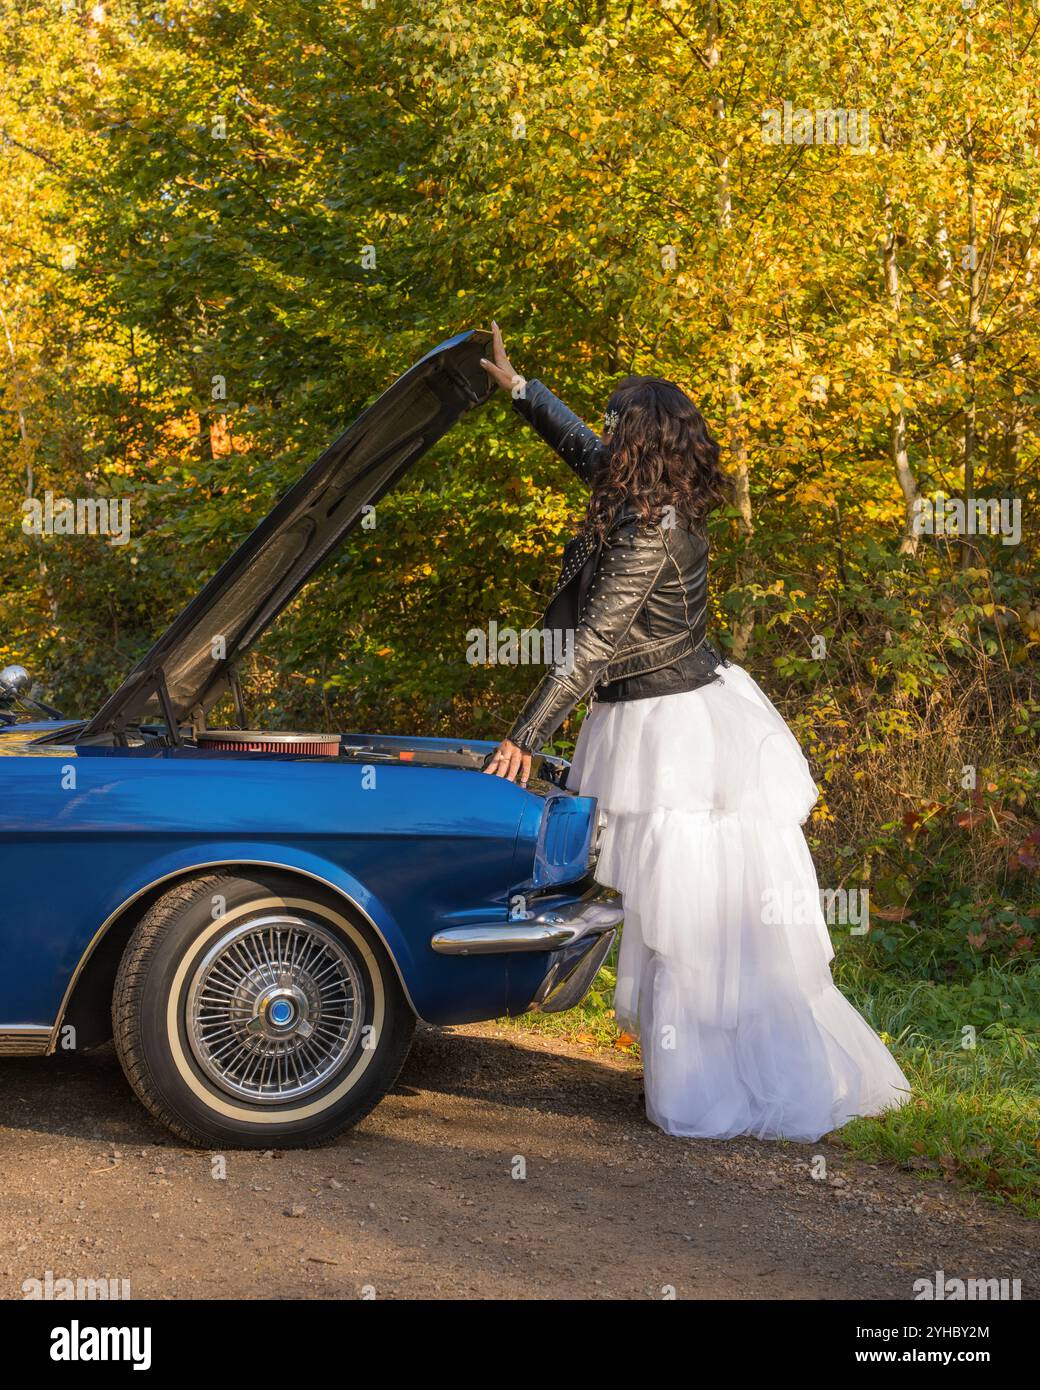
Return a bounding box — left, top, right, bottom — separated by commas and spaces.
186, 913, 364, 1104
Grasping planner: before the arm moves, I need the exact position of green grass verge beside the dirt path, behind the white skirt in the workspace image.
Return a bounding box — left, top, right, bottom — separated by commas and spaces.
509, 952, 1040, 1218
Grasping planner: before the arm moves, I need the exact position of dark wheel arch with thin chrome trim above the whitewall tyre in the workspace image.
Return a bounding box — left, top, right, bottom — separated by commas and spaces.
56, 859, 414, 1051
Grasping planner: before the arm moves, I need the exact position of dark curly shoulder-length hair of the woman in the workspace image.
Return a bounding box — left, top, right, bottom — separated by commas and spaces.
585, 377, 730, 537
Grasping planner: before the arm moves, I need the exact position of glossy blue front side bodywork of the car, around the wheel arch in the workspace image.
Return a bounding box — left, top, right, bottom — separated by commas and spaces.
0, 726, 570, 1026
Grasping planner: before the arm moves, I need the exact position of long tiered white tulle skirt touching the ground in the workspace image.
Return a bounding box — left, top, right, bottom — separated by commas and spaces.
570, 666, 909, 1140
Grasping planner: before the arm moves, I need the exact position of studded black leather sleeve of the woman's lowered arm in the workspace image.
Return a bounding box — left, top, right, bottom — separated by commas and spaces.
507, 523, 667, 752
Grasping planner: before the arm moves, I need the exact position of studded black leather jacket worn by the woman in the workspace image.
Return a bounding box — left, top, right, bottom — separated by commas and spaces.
509, 381, 722, 752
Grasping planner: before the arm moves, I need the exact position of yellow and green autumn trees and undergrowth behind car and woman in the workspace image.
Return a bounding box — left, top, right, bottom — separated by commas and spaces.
0, 0, 1040, 1211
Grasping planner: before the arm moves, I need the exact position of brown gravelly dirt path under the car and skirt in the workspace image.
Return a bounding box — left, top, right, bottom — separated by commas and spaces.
0, 1024, 1040, 1300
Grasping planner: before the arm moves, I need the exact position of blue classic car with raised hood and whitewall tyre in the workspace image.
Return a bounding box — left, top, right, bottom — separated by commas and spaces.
0, 332, 621, 1148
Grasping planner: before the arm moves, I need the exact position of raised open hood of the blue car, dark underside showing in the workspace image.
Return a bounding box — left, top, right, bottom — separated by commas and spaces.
79, 329, 495, 739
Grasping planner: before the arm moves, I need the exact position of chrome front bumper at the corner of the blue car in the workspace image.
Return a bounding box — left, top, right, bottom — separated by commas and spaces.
430, 888, 624, 1013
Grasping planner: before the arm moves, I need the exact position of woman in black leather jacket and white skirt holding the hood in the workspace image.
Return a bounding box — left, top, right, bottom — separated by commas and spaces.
482, 325, 908, 1140
